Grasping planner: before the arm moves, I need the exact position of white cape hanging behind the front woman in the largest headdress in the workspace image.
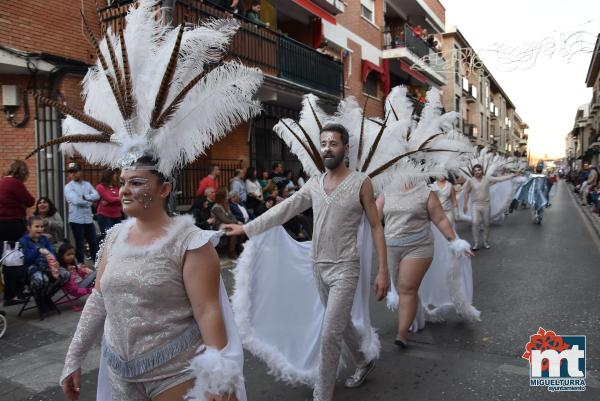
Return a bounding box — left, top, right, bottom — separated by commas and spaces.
96, 279, 247, 401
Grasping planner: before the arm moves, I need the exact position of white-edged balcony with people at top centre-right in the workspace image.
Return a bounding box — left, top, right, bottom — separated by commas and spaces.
382, 24, 446, 86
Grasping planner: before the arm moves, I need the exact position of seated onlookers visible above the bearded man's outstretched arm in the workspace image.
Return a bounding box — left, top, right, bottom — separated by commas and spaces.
189, 163, 312, 257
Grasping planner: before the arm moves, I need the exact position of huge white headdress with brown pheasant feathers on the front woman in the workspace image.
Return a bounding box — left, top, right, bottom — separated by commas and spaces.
32, 0, 262, 176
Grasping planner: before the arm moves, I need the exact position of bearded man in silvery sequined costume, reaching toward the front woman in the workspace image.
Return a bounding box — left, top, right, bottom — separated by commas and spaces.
225, 125, 389, 401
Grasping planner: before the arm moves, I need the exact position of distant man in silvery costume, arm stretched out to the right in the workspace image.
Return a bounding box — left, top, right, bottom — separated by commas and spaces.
463, 164, 514, 251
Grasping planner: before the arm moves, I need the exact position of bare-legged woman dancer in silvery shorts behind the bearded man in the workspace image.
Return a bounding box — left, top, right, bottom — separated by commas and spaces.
377, 90, 479, 348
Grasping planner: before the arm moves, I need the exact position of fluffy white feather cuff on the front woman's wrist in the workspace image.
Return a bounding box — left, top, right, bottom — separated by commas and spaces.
186, 346, 244, 401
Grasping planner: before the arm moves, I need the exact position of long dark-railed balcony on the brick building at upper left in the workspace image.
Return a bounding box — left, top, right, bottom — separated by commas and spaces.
100, 0, 344, 97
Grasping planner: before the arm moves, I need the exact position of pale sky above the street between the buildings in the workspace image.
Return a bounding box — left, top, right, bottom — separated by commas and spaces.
441, 0, 600, 160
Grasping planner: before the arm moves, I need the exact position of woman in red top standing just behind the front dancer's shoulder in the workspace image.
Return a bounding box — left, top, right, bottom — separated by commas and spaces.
96, 169, 122, 238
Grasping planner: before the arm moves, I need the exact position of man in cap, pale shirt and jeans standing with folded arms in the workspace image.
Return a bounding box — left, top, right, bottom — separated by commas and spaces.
65, 163, 100, 263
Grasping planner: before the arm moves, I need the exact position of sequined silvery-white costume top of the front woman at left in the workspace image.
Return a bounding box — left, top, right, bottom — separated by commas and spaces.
61, 216, 218, 381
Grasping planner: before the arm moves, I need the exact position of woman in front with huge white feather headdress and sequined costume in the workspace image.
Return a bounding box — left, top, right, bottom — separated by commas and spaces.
25, 0, 262, 401
